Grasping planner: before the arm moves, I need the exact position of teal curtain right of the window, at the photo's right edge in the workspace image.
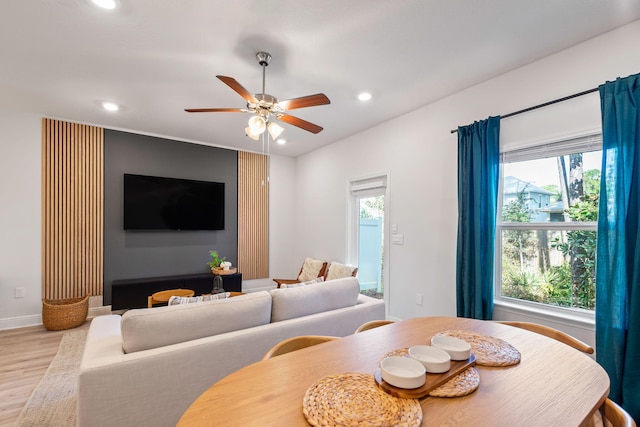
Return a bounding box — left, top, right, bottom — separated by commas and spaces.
596, 74, 640, 420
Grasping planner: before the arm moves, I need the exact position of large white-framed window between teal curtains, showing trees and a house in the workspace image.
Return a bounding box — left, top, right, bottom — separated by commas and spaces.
496, 135, 602, 311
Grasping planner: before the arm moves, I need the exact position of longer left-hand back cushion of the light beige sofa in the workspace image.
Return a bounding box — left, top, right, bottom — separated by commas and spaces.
120, 291, 271, 353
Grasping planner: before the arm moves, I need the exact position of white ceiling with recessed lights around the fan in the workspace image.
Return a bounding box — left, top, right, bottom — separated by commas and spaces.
0, 0, 640, 156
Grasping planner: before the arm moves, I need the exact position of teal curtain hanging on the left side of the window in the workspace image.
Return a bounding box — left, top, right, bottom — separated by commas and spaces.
456, 117, 500, 320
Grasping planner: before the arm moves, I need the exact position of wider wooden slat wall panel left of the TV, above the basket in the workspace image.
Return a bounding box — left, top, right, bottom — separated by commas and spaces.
42, 118, 104, 299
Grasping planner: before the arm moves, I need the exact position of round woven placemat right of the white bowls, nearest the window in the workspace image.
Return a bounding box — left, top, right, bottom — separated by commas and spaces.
434, 330, 520, 366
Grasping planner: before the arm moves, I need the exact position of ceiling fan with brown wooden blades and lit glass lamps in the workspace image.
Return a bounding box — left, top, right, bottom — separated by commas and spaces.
185, 52, 331, 140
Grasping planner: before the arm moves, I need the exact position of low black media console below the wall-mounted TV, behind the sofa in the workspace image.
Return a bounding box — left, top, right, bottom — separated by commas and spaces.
111, 273, 242, 310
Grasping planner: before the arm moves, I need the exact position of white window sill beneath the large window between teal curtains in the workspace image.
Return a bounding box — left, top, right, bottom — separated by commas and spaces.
494, 298, 595, 331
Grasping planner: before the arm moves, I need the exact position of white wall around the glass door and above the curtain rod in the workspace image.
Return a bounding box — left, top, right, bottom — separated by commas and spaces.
293, 21, 640, 326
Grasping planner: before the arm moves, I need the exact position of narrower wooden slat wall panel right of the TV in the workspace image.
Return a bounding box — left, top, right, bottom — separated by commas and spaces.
238, 151, 269, 280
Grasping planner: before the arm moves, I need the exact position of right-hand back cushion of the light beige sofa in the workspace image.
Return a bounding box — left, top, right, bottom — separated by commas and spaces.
270, 277, 360, 322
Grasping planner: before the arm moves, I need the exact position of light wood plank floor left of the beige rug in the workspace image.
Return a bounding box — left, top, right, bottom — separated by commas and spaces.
0, 326, 65, 427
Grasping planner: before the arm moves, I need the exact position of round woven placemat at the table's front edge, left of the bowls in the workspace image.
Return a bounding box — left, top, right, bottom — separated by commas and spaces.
302, 373, 422, 427
